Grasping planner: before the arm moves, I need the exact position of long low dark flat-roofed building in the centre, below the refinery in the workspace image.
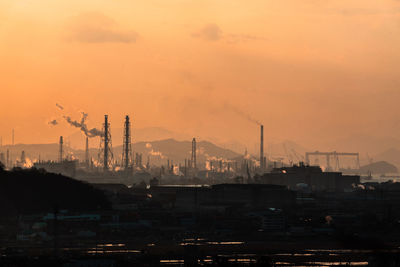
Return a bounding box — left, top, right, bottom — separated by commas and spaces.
150, 184, 296, 211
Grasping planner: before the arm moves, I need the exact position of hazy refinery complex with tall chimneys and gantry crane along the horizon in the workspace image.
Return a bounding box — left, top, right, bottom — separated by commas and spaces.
0, 115, 360, 191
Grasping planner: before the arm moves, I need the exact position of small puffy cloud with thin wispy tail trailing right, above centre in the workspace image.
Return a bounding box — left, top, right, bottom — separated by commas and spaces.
192, 23, 267, 44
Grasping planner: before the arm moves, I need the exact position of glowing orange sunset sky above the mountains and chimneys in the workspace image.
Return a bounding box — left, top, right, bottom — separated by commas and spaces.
0, 0, 400, 152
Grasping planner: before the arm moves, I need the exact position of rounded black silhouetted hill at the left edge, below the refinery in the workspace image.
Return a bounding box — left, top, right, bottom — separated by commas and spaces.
0, 169, 110, 215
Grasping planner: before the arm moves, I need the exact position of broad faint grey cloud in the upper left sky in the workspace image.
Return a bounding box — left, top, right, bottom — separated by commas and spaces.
69, 13, 139, 43
